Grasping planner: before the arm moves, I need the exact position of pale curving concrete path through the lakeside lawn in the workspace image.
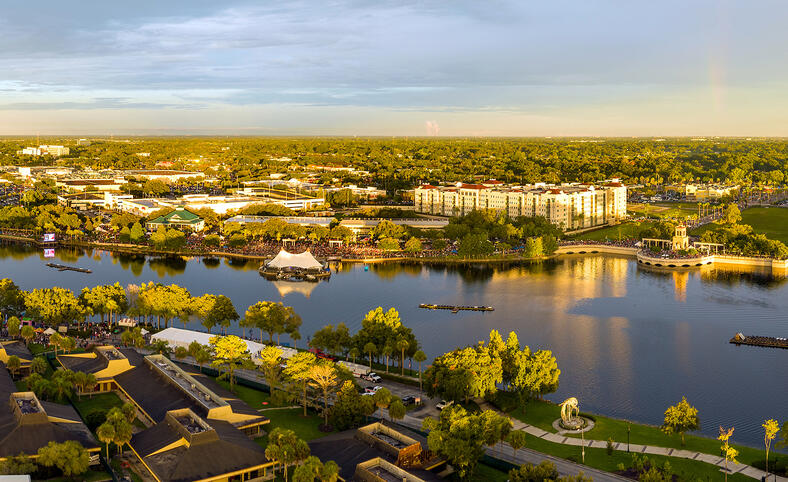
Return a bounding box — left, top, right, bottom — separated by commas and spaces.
474, 399, 788, 482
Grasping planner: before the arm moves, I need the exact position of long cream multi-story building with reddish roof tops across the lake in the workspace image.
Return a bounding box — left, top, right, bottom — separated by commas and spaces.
414, 180, 627, 230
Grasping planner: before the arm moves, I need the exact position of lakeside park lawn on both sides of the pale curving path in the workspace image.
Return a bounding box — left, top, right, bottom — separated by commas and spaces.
490, 392, 788, 481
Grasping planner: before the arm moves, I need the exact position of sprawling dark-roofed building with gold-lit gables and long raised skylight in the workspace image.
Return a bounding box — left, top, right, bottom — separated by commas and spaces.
57, 346, 274, 482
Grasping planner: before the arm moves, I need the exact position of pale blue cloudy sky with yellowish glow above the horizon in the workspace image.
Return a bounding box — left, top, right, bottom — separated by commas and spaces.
0, 0, 788, 136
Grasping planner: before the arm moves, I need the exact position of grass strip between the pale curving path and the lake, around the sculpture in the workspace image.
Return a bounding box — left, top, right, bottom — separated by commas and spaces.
510, 400, 788, 465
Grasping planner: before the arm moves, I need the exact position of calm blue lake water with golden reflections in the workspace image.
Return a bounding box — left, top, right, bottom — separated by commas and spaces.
0, 244, 788, 446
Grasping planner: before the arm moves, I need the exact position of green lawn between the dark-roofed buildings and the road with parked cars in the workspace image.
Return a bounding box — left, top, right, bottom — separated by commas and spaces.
217, 380, 326, 447
